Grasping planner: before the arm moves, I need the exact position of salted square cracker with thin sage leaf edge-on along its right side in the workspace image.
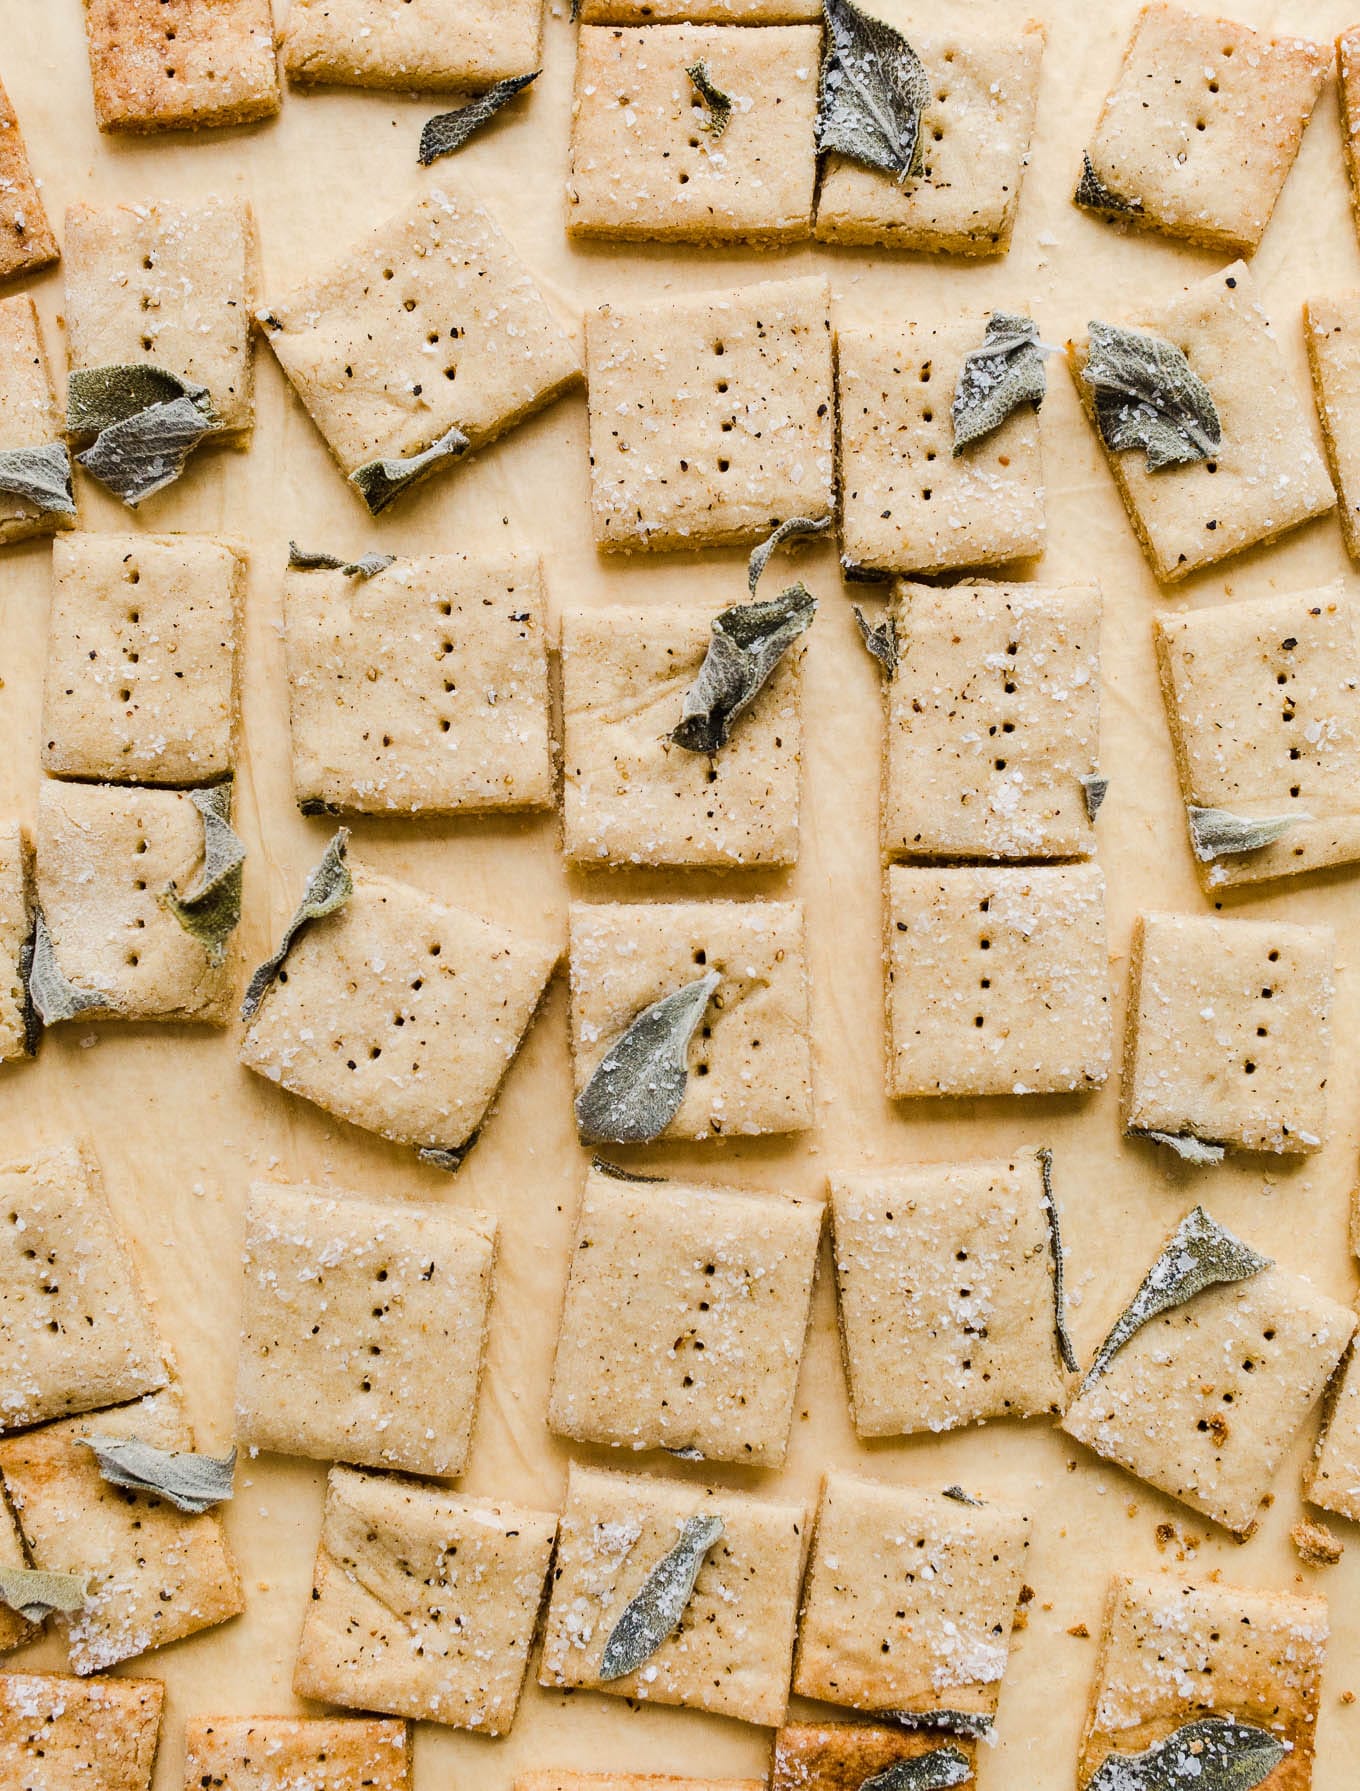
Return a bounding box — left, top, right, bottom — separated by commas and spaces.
831, 1155, 1066, 1436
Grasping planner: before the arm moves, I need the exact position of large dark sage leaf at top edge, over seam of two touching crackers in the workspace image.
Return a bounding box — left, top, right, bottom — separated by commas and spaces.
817, 0, 930, 183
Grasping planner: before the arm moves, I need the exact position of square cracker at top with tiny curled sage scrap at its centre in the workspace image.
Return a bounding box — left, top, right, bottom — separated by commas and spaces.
566, 25, 821, 244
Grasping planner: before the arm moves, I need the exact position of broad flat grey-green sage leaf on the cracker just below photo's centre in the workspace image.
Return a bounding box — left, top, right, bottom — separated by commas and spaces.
575, 971, 722, 1144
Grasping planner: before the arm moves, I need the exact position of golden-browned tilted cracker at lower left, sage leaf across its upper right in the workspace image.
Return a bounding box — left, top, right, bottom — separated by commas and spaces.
0, 1390, 245, 1675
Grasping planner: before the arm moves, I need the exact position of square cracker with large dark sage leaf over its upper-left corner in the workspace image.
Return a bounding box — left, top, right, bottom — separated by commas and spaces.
813, 13, 1045, 254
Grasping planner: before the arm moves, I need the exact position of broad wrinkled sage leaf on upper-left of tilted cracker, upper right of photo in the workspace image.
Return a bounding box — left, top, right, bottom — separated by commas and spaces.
1082, 322, 1224, 473
